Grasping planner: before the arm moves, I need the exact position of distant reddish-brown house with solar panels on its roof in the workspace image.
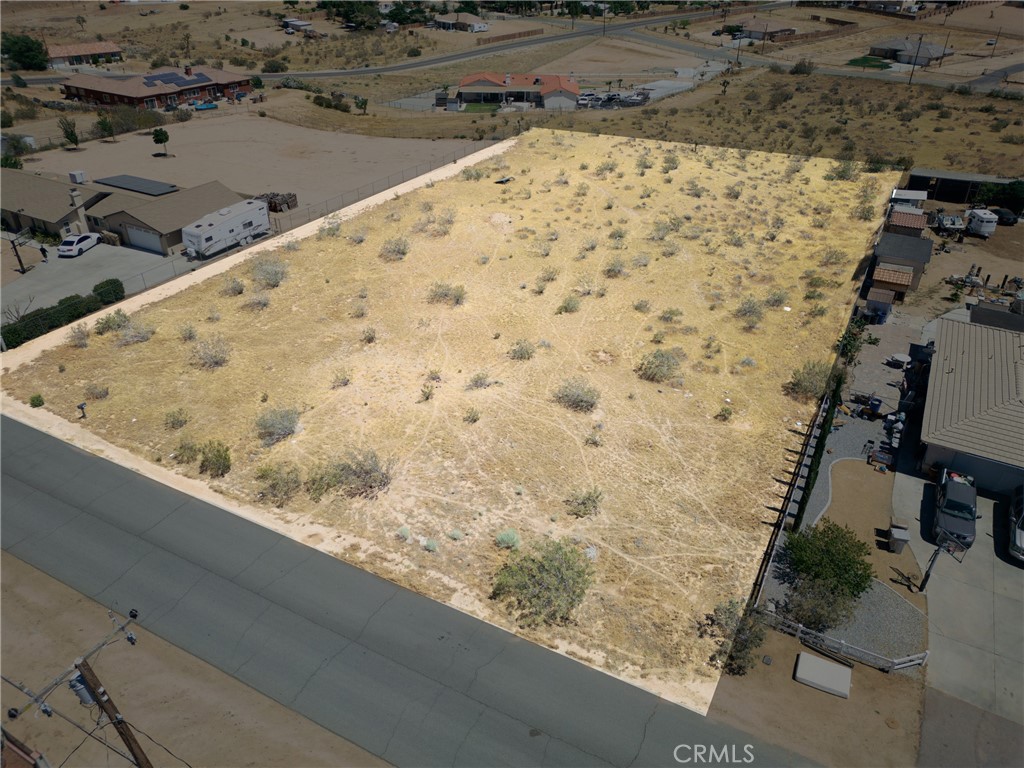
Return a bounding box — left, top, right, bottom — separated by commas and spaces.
60, 67, 253, 110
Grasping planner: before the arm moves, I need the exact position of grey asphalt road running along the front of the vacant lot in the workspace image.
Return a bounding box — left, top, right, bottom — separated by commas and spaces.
0, 417, 807, 766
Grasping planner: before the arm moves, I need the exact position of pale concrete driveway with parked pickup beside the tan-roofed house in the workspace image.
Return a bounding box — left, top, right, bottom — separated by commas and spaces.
893, 473, 1024, 726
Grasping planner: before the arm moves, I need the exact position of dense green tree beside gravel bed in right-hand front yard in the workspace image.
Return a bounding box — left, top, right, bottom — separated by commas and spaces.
782, 518, 874, 599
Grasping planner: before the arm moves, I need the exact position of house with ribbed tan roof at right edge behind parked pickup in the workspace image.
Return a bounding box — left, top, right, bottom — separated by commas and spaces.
921, 313, 1024, 494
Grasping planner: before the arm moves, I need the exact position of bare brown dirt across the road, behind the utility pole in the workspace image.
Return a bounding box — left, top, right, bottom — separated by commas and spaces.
0, 554, 386, 768
